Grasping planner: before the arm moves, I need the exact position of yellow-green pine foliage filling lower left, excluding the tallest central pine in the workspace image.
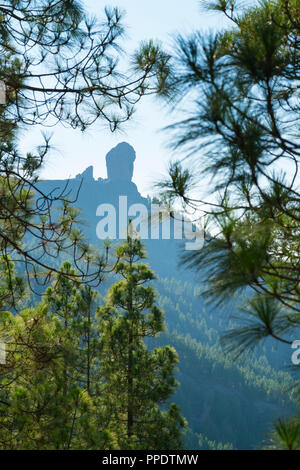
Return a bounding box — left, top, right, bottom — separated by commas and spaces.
0, 262, 115, 449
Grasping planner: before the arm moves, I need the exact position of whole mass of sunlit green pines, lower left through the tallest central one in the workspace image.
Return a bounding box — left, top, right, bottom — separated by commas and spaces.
0, 248, 185, 449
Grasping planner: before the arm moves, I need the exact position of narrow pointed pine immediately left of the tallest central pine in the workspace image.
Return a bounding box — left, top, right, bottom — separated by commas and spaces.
44, 261, 111, 449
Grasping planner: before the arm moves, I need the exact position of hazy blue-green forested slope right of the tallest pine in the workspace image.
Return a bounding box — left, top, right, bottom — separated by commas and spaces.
150, 278, 293, 449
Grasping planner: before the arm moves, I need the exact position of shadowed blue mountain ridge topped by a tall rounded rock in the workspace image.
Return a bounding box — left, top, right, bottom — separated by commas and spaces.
39, 142, 192, 279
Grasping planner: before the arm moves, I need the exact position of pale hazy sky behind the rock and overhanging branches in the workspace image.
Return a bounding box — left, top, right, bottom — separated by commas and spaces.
20, 0, 229, 194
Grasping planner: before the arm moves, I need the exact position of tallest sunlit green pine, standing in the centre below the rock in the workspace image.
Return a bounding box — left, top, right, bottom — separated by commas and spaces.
97, 237, 185, 449
